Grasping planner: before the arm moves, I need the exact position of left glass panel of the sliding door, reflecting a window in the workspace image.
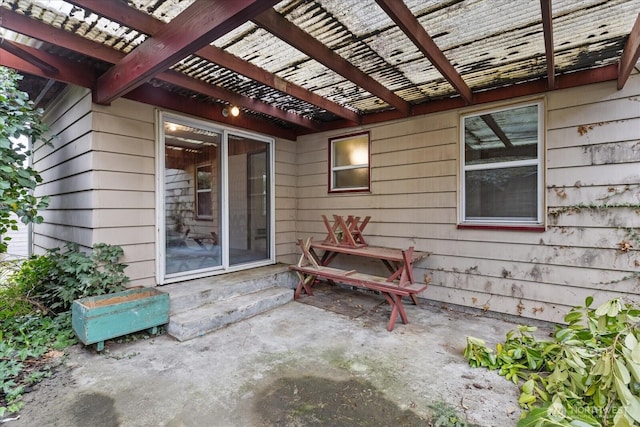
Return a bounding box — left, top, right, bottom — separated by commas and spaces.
164, 121, 222, 275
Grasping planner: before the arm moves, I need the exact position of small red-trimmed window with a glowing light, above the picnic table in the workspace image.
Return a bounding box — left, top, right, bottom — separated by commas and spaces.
329, 132, 370, 193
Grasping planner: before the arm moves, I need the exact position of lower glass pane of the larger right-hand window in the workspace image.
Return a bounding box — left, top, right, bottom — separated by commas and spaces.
465, 166, 538, 221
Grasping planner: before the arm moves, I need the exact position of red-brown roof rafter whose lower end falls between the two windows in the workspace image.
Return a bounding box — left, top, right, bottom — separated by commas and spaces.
252, 9, 411, 116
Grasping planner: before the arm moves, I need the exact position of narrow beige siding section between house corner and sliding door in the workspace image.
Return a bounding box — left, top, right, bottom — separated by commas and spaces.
92, 99, 156, 286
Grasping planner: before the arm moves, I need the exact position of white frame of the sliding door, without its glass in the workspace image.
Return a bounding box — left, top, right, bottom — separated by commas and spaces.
155, 110, 276, 285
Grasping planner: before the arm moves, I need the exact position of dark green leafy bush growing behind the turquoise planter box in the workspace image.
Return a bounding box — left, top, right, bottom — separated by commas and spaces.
12, 243, 129, 313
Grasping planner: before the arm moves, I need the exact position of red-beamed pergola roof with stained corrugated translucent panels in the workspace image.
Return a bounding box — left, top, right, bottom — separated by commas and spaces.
0, 0, 640, 140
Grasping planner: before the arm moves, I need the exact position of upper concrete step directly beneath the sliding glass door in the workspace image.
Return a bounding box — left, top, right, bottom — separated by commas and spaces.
162, 264, 297, 316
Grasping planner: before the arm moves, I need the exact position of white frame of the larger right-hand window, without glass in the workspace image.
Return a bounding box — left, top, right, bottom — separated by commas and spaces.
458, 100, 546, 229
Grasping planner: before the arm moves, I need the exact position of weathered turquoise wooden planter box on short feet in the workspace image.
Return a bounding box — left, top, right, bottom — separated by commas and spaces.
71, 288, 169, 351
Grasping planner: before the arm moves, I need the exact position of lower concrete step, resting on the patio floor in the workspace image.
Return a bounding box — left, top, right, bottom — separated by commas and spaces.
167, 286, 293, 341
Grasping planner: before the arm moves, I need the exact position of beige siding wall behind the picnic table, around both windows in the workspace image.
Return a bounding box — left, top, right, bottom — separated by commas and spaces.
297, 73, 640, 321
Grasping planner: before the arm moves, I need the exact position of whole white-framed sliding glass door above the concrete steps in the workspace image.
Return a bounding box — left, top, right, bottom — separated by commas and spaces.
157, 113, 274, 283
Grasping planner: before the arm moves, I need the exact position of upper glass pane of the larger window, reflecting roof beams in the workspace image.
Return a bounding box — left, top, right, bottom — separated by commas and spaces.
464, 105, 539, 165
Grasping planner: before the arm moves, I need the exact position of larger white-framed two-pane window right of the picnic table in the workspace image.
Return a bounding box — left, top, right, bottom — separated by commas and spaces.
461, 102, 544, 226
